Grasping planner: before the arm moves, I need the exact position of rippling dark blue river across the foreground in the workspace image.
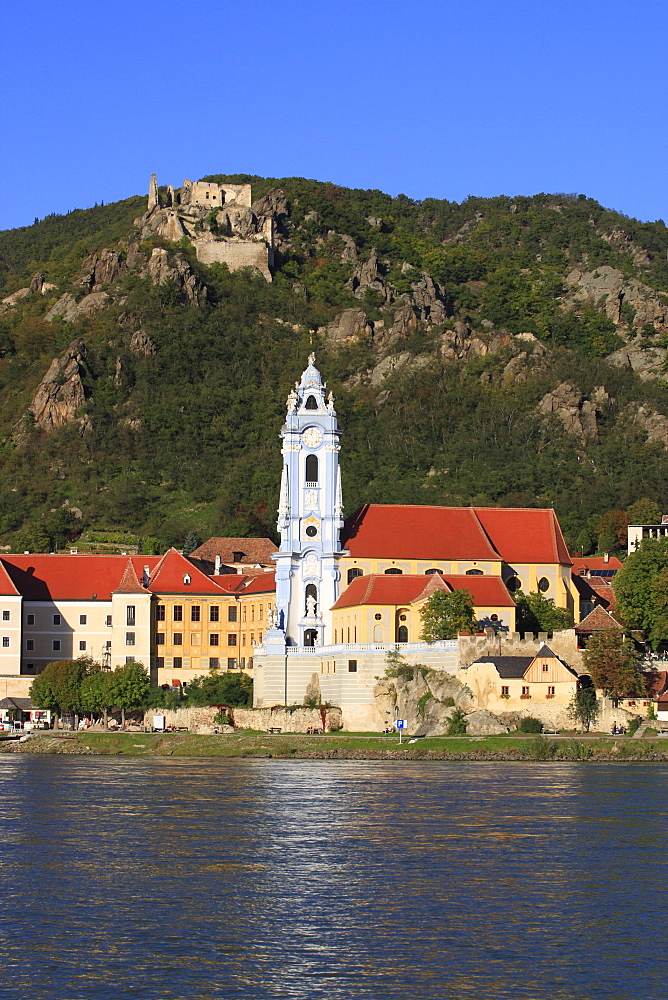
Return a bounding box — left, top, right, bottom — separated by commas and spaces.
0, 755, 668, 1000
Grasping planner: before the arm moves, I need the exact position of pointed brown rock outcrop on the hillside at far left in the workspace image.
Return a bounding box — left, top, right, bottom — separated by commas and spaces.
28, 340, 90, 434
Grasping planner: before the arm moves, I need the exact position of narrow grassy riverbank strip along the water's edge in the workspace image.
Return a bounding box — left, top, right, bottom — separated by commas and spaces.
0, 732, 668, 761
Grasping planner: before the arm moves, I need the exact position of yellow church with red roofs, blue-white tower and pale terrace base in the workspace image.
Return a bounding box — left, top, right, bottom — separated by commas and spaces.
254, 355, 578, 724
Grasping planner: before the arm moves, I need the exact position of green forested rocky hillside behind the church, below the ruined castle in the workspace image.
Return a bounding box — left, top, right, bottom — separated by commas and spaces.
0, 175, 668, 552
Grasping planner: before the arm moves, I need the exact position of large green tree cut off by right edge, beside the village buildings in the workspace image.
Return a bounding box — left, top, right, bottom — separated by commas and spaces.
612, 538, 668, 647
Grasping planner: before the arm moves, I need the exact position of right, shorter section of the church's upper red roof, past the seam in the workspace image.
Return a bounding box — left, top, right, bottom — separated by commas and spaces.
474, 507, 571, 566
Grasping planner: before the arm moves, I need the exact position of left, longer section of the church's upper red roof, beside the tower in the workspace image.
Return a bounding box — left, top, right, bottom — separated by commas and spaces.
341, 504, 499, 561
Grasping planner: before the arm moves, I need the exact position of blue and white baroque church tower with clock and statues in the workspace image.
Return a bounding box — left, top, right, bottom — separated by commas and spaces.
266, 354, 343, 646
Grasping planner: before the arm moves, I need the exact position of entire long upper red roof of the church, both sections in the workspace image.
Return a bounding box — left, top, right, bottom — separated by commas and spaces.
341, 504, 571, 566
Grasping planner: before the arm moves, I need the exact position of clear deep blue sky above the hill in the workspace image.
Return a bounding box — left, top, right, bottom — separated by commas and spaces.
0, 0, 668, 229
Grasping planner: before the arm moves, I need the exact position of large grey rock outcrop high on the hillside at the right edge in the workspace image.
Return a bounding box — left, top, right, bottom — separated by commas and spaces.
566, 265, 668, 330
